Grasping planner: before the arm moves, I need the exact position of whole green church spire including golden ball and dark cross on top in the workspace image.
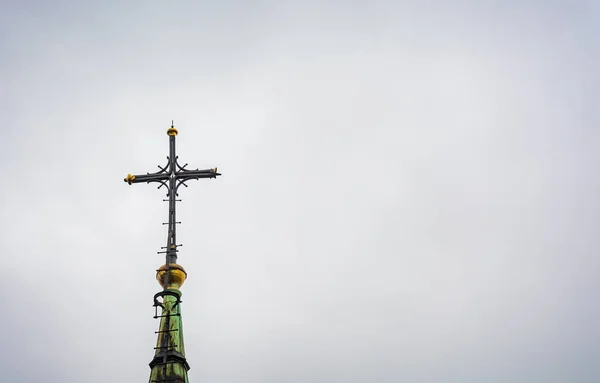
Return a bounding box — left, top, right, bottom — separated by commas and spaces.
124, 122, 221, 383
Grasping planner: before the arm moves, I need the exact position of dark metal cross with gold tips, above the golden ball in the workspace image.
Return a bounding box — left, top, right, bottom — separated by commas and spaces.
123, 121, 221, 268
